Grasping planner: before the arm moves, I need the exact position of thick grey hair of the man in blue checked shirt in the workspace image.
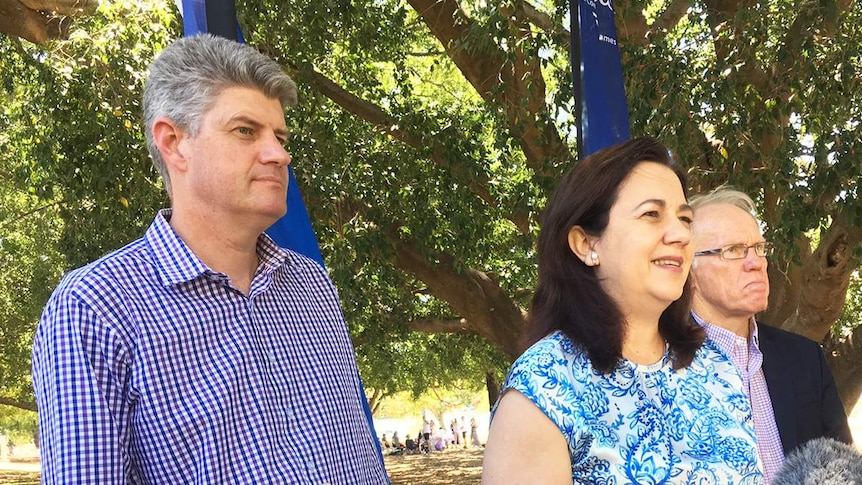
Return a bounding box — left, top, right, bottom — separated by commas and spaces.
143, 34, 297, 195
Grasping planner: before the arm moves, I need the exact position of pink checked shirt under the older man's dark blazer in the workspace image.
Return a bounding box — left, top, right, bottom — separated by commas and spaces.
692, 312, 784, 483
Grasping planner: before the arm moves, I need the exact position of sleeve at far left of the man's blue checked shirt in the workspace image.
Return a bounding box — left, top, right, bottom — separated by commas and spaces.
33, 289, 131, 484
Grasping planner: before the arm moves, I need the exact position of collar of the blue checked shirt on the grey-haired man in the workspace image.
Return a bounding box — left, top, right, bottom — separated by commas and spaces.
144, 209, 289, 286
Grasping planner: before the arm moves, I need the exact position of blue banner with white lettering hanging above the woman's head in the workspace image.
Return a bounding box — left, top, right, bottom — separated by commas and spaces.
569, 0, 631, 159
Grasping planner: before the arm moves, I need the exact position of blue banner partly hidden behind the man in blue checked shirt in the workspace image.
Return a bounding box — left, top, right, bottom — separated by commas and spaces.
177, 0, 383, 461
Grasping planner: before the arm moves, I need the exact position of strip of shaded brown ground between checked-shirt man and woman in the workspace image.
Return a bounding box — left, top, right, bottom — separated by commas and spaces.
385, 449, 483, 485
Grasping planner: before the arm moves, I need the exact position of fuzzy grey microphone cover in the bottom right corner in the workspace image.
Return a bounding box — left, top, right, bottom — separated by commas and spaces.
772, 437, 862, 485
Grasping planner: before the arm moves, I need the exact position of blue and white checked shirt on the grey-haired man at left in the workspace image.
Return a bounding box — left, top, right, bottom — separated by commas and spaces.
33, 211, 388, 485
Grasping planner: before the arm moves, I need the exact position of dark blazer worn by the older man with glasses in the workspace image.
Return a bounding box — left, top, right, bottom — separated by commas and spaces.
757, 322, 853, 455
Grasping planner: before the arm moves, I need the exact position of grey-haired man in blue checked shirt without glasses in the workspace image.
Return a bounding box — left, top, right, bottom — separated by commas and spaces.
33, 36, 388, 485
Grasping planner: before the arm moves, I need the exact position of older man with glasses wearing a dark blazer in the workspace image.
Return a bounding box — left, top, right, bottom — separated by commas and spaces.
690, 187, 852, 483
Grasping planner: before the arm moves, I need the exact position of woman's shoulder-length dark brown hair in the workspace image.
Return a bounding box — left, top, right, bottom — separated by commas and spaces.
526, 138, 705, 373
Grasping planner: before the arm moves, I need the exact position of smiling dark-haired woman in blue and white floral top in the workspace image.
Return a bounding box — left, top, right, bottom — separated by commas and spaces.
482, 138, 763, 484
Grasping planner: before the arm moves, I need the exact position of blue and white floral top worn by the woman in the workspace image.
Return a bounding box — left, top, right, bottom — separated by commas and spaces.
495, 331, 763, 485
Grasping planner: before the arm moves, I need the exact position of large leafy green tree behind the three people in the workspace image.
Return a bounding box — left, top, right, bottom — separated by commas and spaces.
3, 0, 862, 407
